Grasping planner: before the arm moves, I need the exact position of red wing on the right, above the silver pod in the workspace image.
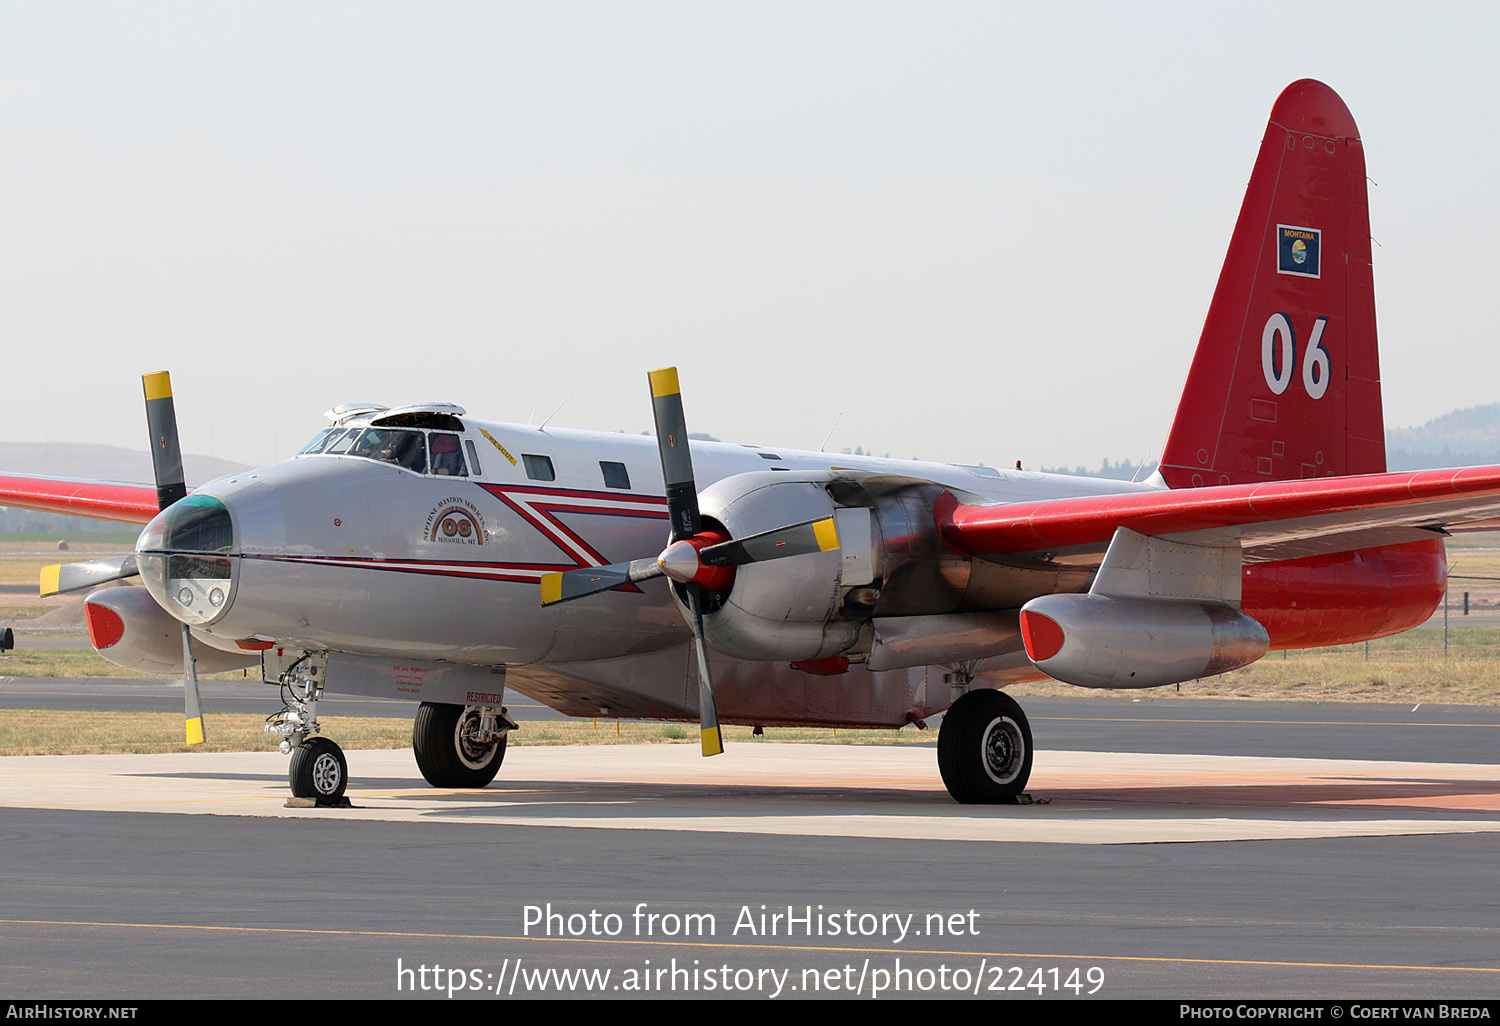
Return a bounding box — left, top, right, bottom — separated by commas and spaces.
939, 467, 1500, 564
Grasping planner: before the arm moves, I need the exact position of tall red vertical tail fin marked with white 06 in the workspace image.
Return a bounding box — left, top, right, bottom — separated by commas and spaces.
1161, 80, 1386, 488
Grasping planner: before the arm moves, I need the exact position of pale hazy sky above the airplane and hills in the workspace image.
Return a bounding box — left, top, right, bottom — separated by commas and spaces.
0, 0, 1500, 470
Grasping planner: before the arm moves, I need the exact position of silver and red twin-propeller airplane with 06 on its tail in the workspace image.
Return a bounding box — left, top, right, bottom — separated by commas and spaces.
0, 80, 1500, 804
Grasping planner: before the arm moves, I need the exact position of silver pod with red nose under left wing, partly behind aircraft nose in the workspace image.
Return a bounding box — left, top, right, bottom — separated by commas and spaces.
84, 585, 261, 674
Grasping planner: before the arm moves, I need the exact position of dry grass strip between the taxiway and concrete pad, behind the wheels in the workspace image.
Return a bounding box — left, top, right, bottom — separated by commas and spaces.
0, 710, 938, 756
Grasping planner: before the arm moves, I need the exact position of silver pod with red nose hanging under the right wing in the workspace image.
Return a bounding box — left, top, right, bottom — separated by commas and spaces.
1022, 596, 1271, 689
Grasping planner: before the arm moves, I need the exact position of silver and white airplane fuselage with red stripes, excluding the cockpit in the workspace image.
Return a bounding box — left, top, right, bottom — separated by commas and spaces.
141, 419, 1154, 726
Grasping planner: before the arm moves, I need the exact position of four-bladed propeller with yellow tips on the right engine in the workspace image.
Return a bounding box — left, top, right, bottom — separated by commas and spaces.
542, 368, 839, 756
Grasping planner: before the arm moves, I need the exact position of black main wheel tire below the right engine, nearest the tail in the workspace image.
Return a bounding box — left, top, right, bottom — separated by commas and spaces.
938, 689, 1032, 806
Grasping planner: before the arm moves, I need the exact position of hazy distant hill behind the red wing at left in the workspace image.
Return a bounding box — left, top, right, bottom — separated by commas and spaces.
0, 443, 249, 531
